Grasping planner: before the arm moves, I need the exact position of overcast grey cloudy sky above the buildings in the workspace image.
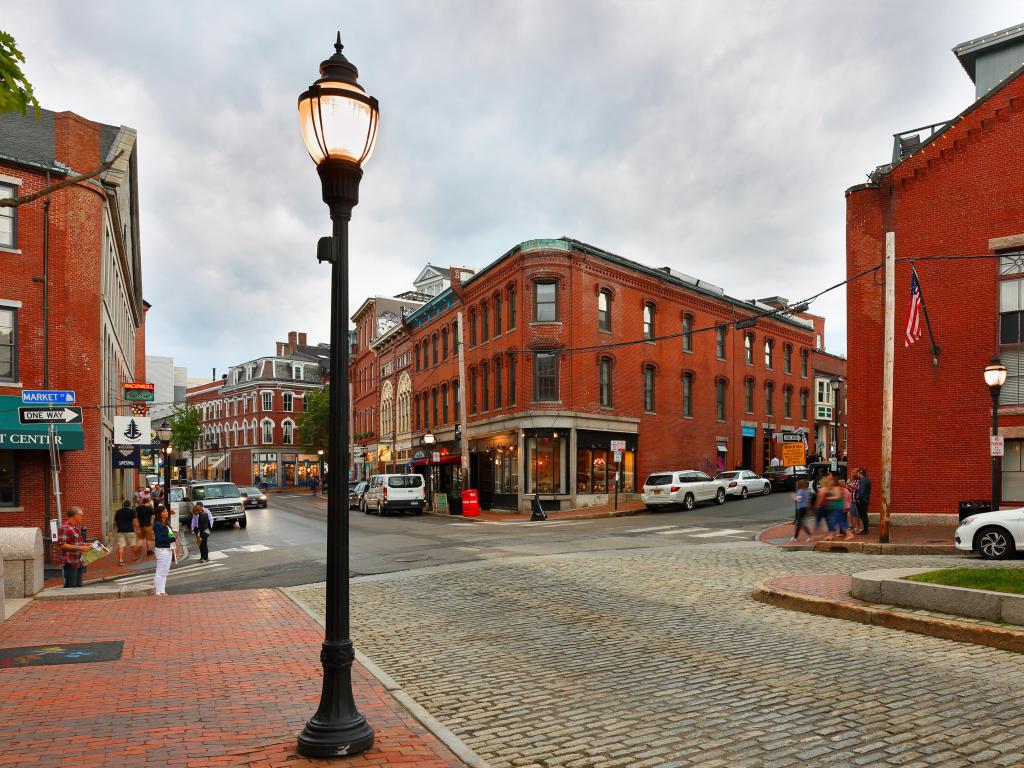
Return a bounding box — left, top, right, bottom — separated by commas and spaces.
0, 0, 1024, 376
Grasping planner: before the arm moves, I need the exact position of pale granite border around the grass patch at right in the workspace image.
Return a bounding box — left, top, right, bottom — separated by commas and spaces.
850, 568, 1024, 626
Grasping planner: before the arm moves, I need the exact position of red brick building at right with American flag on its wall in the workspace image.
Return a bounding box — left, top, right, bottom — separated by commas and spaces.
846, 27, 1024, 519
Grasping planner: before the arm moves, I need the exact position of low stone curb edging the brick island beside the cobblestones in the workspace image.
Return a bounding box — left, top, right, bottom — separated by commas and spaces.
753, 580, 1024, 653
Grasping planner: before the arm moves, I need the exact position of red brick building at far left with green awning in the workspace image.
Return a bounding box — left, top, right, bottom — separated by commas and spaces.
0, 110, 147, 552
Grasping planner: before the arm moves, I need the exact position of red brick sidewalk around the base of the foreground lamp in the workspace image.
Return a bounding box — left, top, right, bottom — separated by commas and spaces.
0, 590, 463, 768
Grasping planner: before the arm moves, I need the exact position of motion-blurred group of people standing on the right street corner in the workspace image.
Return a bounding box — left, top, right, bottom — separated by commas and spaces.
792, 467, 871, 542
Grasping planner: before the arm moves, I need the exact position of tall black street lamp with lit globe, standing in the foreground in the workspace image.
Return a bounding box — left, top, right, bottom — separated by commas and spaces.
298, 32, 380, 758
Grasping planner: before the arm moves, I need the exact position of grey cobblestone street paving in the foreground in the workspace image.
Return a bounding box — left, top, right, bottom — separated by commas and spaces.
297, 543, 1024, 768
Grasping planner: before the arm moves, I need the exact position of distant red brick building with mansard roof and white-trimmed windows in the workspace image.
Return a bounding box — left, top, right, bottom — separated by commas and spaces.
186, 331, 331, 489
